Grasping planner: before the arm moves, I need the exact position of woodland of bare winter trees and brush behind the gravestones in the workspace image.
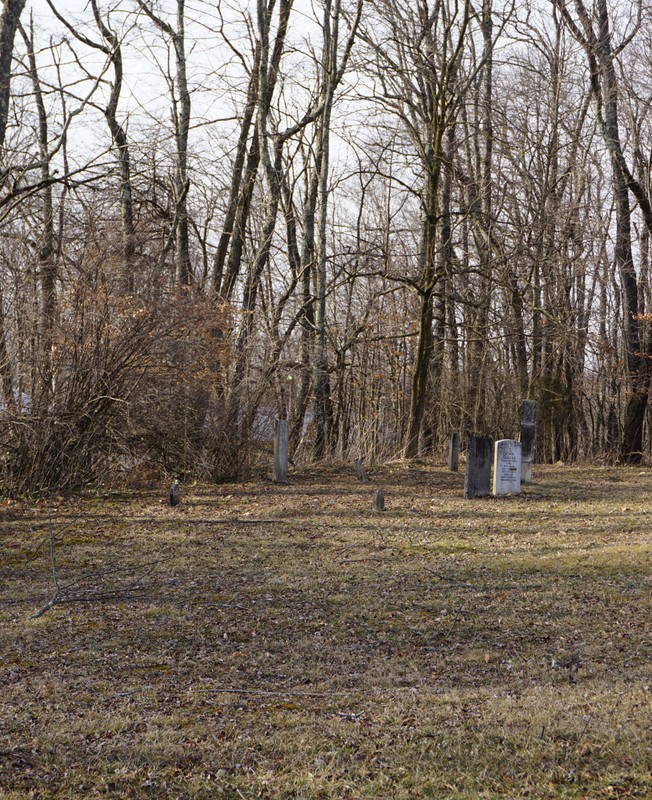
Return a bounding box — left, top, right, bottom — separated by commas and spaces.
0, 0, 652, 492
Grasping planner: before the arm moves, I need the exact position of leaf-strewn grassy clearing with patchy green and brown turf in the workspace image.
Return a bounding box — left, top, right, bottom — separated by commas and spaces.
0, 463, 652, 800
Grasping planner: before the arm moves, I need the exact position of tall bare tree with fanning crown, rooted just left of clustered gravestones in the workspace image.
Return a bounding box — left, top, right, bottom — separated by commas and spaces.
363, 0, 475, 458
